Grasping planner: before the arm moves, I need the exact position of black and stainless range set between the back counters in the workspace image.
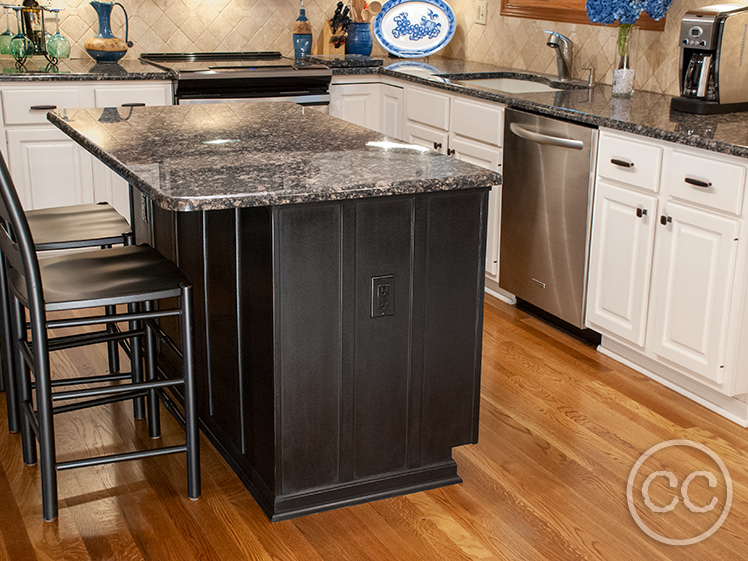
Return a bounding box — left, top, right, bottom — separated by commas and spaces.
140, 51, 332, 106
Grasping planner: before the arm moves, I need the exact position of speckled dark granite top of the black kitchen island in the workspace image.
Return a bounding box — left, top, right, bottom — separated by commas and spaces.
47, 102, 501, 211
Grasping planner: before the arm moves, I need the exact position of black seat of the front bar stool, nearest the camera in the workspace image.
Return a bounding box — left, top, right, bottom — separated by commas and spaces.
9, 245, 189, 312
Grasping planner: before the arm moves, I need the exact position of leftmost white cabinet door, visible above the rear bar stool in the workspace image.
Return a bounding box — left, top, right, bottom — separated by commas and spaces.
6, 127, 94, 210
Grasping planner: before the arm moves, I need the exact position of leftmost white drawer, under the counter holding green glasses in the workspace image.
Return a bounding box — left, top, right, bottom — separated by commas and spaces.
2, 87, 80, 125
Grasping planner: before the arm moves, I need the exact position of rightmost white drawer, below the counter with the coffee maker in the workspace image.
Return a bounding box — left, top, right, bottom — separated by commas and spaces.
665, 150, 745, 214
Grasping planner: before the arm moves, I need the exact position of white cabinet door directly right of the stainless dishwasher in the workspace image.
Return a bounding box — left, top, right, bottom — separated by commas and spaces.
586, 179, 658, 347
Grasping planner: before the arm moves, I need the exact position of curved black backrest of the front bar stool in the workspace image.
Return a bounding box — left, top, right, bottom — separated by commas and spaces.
0, 154, 46, 333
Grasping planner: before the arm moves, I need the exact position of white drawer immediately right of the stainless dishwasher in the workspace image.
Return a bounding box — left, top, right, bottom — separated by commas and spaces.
597, 131, 662, 192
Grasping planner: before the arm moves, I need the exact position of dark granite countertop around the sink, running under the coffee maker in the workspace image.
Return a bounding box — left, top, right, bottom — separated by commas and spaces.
318, 56, 748, 158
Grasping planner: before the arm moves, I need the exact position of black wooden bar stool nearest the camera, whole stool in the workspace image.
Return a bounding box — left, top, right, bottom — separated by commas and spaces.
0, 153, 200, 521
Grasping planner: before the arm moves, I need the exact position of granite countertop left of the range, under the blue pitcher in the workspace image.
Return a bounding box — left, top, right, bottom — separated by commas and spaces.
0, 55, 173, 82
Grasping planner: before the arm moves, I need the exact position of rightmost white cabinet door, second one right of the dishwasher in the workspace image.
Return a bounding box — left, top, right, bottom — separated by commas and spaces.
652, 203, 739, 385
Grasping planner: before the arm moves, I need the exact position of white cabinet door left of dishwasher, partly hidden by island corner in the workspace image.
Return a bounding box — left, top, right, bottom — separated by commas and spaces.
449, 133, 501, 280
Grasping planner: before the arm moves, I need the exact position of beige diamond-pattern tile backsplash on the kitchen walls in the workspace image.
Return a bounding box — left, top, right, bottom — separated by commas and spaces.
45, 0, 736, 94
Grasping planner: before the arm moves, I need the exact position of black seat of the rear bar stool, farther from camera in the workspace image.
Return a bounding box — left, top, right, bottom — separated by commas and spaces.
26, 203, 131, 251
